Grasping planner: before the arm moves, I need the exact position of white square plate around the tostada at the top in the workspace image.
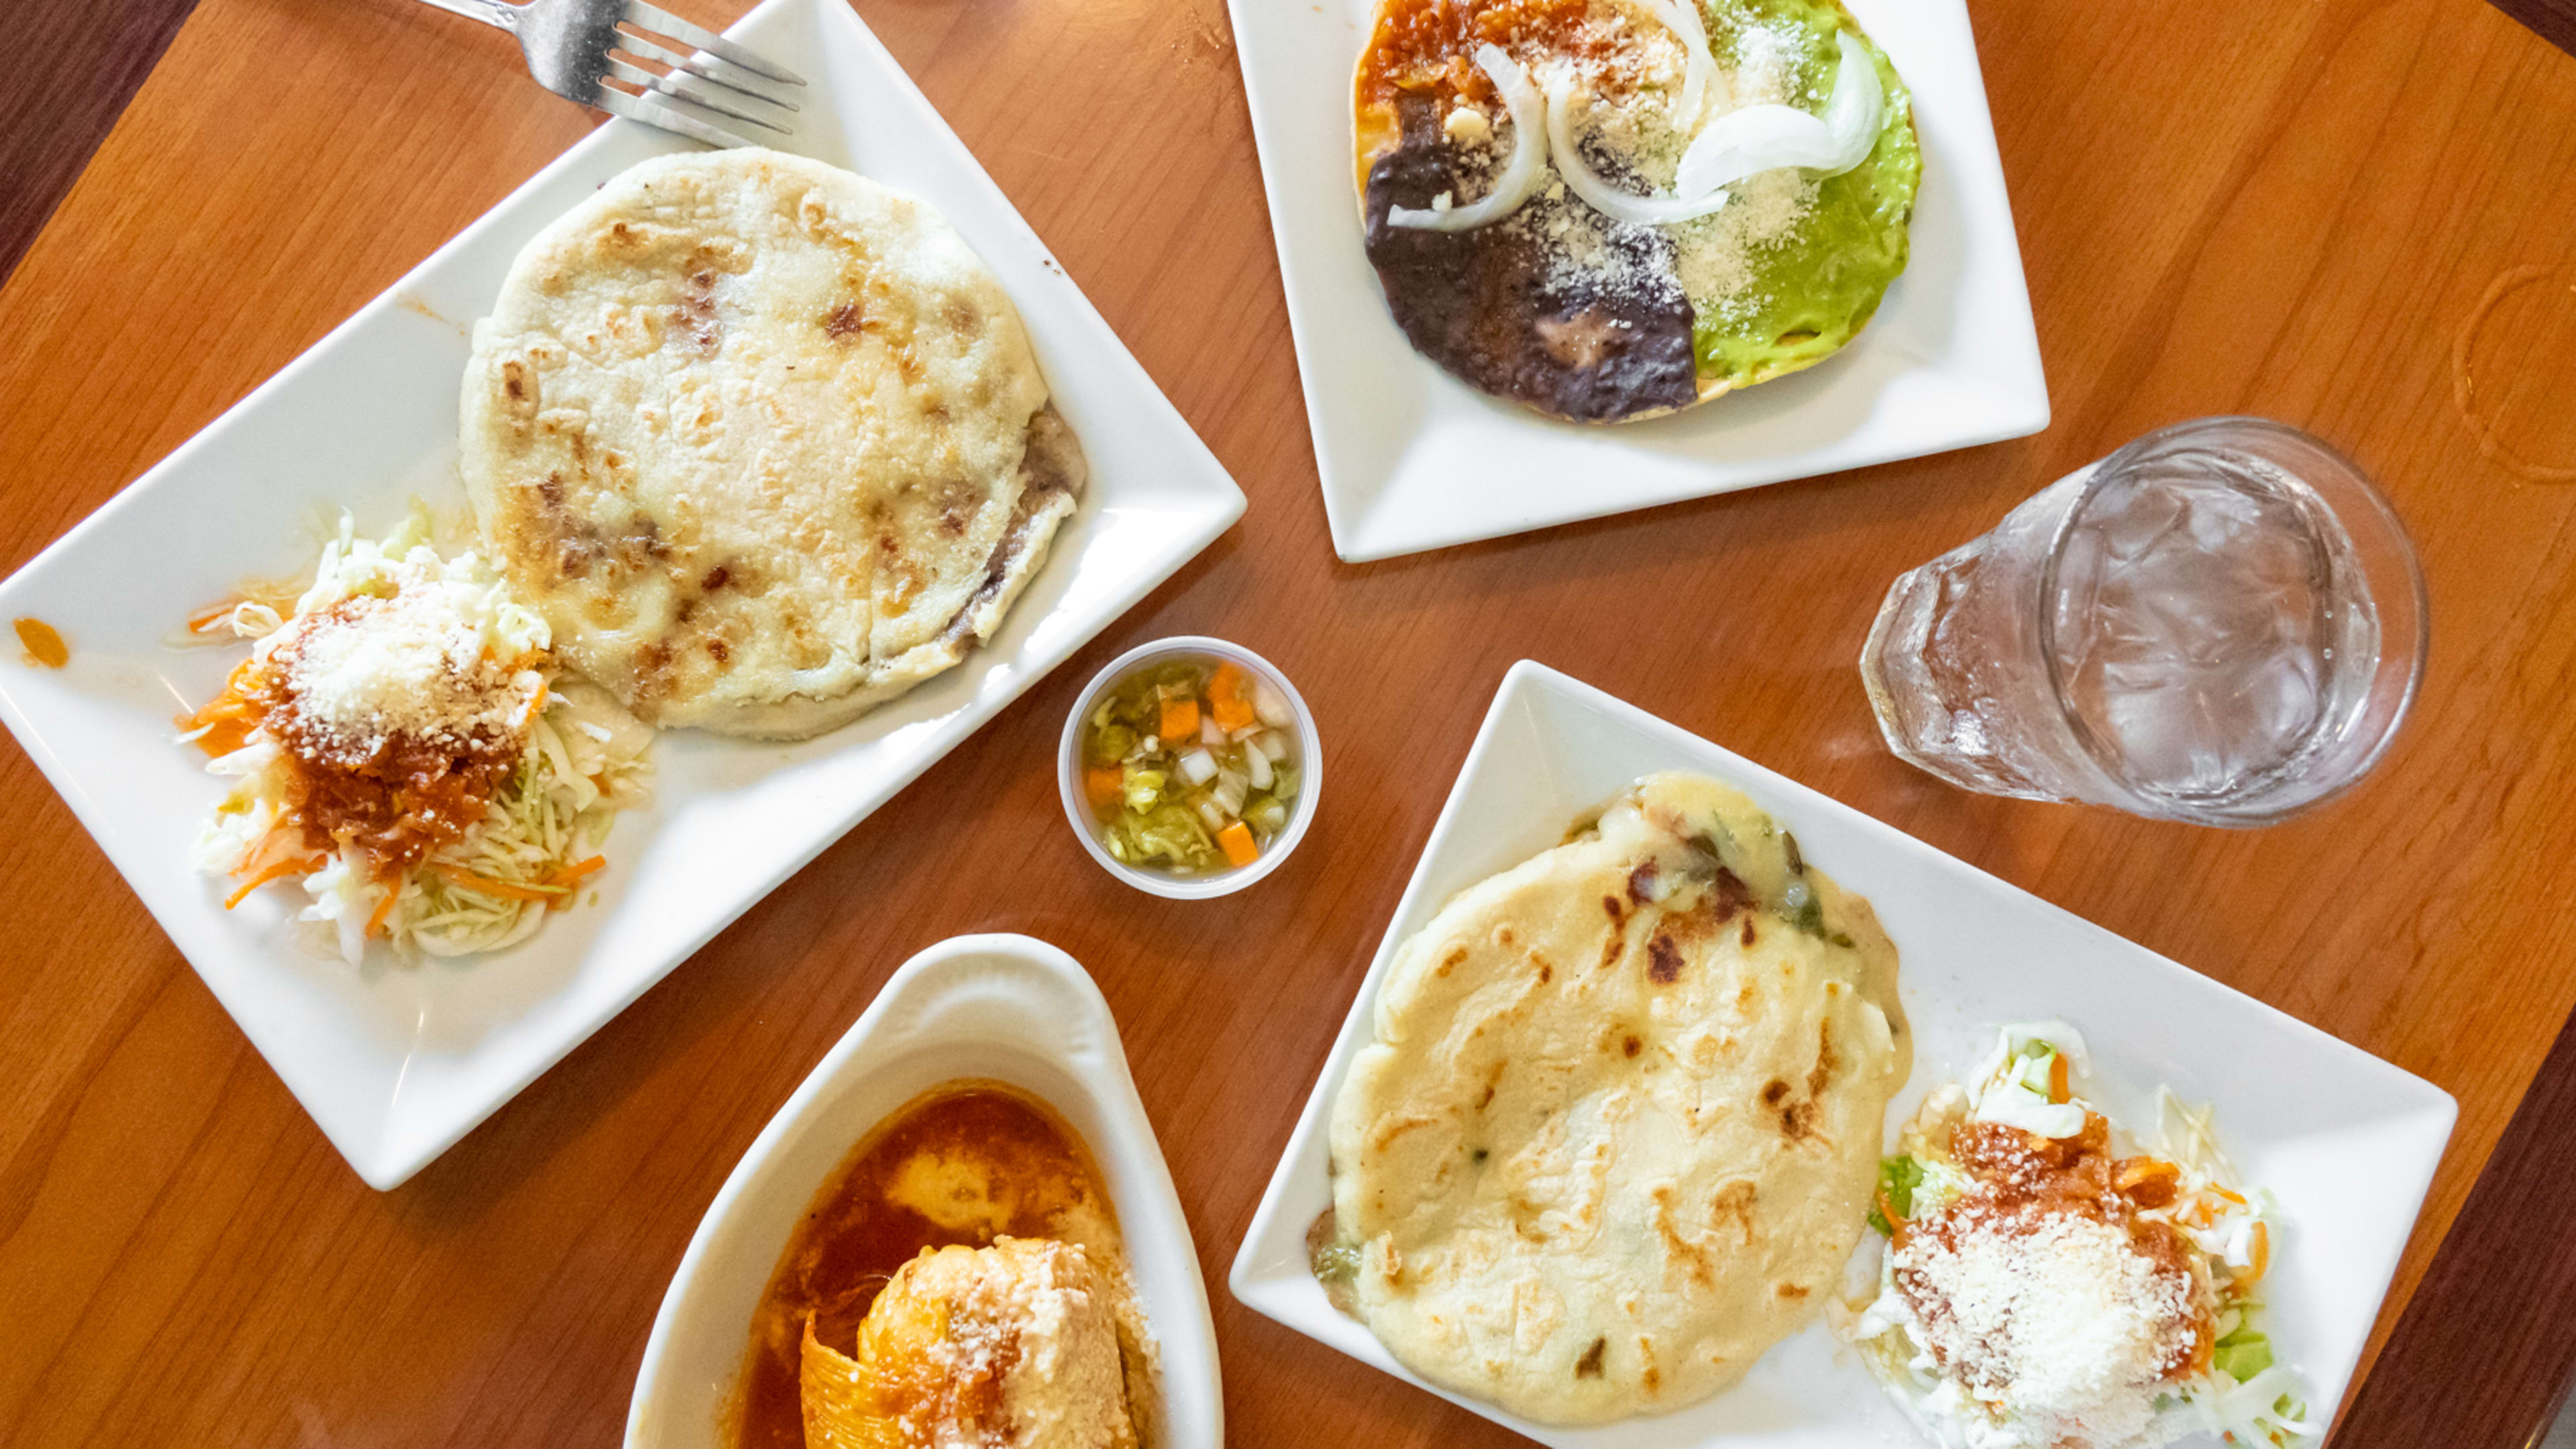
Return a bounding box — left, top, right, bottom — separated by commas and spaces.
1229, 0, 2048, 562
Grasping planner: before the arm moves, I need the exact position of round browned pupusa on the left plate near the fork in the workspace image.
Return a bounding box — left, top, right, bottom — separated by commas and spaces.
461, 150, 1082, 737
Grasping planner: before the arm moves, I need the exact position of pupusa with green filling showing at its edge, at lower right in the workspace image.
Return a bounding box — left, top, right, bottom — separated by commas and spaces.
1332, 773, 1911, 1424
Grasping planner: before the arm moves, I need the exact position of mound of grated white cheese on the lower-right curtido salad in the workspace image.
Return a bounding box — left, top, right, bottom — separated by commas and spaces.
1893, 1210, 2192, 1446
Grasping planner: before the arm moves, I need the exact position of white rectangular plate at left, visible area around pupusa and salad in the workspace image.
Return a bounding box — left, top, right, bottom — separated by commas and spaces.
0, 0, 1244, 1189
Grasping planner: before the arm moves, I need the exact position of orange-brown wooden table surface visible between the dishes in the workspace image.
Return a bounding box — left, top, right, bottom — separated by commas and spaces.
0, 0, 2576, 1449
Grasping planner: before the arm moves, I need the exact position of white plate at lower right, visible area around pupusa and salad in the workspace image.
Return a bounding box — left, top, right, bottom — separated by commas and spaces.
1232, 660, 2457, 1449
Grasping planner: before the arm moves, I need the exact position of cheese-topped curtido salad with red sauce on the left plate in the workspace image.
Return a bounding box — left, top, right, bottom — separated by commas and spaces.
180, 508, 652, 964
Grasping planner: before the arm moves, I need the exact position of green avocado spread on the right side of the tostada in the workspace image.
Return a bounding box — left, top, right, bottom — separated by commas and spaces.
1674, 0, 1924, 387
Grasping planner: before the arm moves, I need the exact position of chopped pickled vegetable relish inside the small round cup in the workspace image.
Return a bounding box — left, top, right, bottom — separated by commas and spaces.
1082, 657, 1298, 877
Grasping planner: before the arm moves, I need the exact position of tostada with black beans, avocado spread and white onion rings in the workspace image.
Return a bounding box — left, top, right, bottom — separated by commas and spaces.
1352, 0, 1922, 423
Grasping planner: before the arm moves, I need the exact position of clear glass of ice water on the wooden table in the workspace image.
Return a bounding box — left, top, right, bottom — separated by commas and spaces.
1860, 418, 2426, 825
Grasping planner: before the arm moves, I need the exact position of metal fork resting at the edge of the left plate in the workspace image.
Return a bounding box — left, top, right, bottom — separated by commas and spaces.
427, 0, 804, 147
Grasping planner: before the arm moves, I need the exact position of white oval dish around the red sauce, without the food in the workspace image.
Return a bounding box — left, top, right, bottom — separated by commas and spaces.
626, 936, 1226, 1449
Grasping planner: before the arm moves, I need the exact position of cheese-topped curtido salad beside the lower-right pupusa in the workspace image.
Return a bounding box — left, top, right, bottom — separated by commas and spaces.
1834, 1021, 2310, 1449
